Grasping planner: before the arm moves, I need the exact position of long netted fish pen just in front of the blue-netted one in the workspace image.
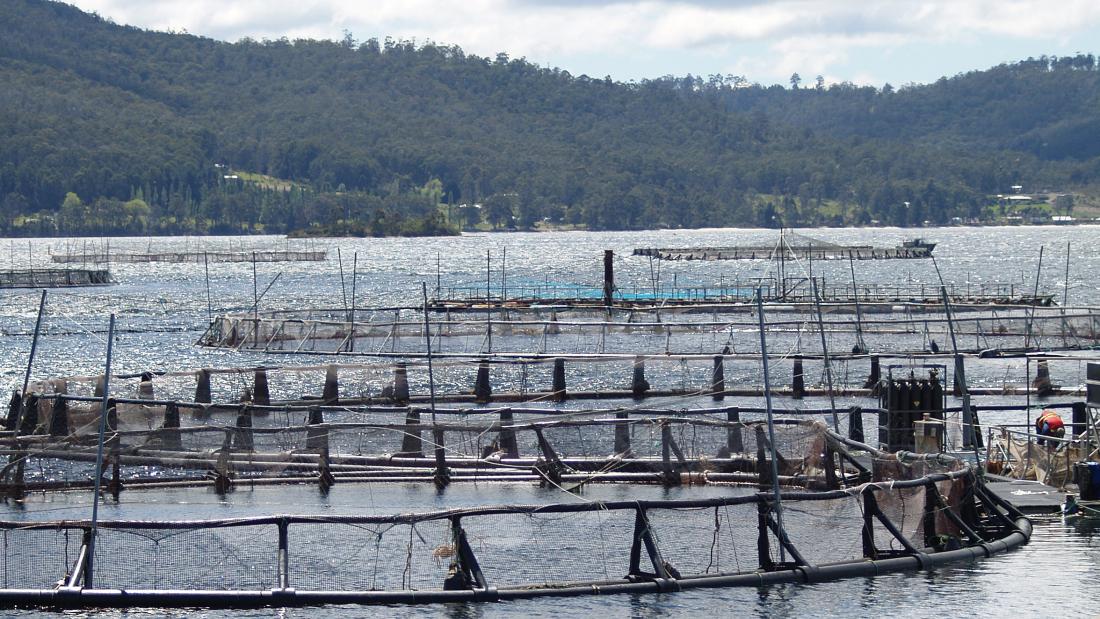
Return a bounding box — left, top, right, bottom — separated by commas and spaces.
197, 305, 1100, 356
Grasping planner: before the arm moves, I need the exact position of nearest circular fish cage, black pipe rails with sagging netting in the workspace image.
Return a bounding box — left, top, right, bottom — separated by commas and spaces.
0, 395, 1031, 608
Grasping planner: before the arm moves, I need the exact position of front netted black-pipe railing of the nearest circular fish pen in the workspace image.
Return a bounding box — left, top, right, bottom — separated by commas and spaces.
0, 435, 1031, 607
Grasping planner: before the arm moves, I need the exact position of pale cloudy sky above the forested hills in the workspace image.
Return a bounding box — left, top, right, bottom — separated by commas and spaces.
70, 0, 1100, 87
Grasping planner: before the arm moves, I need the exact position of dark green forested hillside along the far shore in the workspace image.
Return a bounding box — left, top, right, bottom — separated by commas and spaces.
0, 0, 1100, 234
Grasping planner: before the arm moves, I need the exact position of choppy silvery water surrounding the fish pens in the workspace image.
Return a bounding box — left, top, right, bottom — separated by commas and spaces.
0, 226, 1100, 617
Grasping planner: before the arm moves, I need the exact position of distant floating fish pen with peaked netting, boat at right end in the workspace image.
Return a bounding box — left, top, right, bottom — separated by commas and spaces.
634, 232, 936, 261
